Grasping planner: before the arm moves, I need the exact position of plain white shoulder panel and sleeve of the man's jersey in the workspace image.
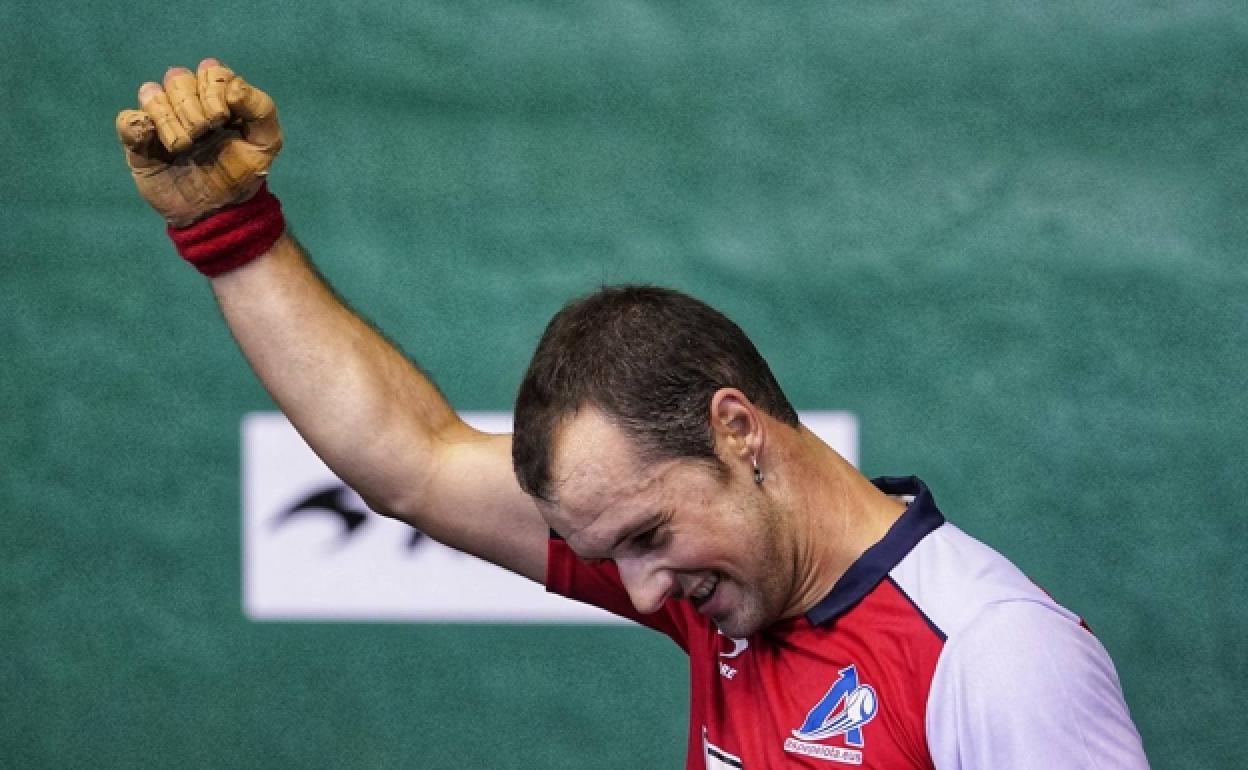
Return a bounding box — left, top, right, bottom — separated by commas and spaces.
892, 524, 1148, 770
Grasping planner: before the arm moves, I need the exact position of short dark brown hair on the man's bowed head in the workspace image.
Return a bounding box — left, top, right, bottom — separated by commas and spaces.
512, 286, 799, 500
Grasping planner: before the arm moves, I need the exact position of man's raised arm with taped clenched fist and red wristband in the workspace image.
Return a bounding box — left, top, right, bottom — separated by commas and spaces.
117, 59, 547, 580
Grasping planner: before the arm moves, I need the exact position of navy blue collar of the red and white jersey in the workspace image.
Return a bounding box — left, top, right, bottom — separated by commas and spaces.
806, 475, 945, 625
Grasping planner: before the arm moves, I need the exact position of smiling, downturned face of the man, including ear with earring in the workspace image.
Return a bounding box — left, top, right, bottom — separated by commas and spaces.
538, 399, 788, 638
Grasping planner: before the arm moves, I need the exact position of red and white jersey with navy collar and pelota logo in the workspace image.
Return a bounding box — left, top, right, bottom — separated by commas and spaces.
547, 477, 1148, 770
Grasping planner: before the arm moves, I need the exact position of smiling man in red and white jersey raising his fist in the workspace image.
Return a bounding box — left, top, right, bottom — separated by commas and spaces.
117, 59, 1147, 770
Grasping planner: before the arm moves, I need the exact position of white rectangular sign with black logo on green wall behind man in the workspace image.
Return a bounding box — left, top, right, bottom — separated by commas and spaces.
242, 412, 859, 623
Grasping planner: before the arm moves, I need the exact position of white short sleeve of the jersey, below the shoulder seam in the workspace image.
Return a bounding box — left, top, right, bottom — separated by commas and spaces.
926, 600, 1148, 770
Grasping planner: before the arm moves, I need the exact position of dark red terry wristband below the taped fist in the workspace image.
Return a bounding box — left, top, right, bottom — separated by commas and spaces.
166, 182, 286, 278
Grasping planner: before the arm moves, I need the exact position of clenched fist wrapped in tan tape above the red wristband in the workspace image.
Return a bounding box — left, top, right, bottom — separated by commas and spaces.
117, 59, 282, 227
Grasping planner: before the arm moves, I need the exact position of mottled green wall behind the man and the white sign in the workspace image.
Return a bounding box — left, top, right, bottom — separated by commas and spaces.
0, 0, 1248, 770
